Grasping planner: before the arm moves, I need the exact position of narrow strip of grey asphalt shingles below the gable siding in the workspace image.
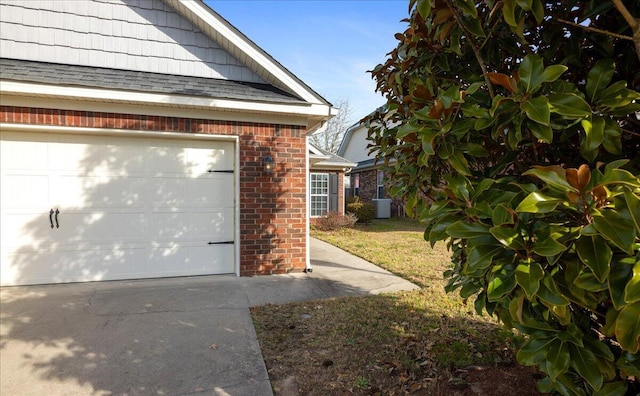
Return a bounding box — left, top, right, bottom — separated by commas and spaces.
0, 58, 305, 104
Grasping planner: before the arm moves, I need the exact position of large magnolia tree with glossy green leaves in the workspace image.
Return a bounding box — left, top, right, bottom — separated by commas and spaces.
369, 0, 640, 395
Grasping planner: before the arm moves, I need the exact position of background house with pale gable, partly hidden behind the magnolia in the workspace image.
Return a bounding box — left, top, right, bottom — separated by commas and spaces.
338, 116, 404, 216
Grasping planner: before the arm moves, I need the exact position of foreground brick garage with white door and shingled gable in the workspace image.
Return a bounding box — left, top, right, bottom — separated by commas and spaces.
0, 0, 338, 285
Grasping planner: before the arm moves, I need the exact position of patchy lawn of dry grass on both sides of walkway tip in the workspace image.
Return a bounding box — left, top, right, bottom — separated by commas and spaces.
252, 219, 518, 395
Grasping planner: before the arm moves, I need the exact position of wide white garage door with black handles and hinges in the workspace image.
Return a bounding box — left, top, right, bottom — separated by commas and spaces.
0, 132, 235, 285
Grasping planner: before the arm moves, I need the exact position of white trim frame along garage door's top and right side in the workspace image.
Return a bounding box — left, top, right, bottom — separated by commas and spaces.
0, 124, 240, 284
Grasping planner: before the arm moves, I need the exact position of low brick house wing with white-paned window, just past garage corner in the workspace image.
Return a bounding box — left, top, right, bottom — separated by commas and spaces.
309, 144, 356, 222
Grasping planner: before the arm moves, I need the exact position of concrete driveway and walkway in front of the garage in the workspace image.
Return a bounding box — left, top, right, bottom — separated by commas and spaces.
0, 239, 417, 395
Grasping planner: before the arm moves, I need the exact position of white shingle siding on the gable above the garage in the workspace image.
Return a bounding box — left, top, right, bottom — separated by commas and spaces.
0, 0, 264, 82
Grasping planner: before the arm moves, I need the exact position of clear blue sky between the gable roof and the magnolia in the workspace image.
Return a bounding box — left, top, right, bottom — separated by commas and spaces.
210, 0, 408, 122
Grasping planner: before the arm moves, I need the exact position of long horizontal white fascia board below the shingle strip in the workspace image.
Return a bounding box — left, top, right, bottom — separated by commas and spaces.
0, 81, 336, 119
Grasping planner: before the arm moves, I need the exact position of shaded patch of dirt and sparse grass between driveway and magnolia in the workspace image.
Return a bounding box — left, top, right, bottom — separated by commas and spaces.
252, 292, 538, 396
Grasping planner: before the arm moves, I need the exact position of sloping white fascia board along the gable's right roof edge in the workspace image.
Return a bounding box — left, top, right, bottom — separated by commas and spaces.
179, 0, 330, 106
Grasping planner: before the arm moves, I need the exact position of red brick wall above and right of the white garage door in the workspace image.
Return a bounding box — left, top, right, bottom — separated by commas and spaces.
0, 106, 307, 275
